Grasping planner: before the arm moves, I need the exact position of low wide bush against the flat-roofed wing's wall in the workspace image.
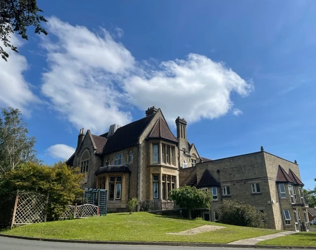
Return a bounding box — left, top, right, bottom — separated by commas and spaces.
218, 200, 264, 227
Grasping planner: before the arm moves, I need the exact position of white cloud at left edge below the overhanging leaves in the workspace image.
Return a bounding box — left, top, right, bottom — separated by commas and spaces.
0, 35, 39, 114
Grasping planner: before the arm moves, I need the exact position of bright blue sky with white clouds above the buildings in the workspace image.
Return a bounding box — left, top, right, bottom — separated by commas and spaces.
0, 0, 316, 188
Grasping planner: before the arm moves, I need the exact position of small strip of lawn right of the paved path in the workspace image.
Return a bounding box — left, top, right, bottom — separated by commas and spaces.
258, 232, 316, 247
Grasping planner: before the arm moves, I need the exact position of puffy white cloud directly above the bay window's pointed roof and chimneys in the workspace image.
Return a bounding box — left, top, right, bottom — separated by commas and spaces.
124, 54, 252, 124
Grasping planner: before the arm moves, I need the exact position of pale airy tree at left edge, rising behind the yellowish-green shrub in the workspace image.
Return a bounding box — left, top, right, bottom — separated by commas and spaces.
0, 108, 37, 173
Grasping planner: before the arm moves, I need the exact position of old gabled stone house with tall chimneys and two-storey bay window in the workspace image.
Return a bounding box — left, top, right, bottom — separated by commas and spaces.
66, 107, 201, 211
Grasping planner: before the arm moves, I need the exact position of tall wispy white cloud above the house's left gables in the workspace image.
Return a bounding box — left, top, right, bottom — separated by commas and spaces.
42, 17, 134, 133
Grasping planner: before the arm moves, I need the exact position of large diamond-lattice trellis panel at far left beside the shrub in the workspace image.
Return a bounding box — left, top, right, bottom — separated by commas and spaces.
11, 192, 48, 228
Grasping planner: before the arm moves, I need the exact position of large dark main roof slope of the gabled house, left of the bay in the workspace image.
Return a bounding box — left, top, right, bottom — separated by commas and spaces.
103, 114, 154, 154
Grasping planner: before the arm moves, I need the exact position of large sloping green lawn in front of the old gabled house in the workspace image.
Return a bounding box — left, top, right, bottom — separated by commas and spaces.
2, 212, 277, 243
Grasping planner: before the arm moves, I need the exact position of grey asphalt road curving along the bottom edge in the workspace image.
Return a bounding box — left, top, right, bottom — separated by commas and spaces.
0, 236, 304, 250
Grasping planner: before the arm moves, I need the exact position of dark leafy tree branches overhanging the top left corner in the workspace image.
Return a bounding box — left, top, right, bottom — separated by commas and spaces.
0, 0, 47, 61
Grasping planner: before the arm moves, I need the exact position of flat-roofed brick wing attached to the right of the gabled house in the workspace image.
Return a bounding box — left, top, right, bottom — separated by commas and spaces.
180, 148, 309, 231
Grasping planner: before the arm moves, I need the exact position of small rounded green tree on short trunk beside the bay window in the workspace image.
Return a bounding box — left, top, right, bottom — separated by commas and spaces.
170, 186, 212, 219
